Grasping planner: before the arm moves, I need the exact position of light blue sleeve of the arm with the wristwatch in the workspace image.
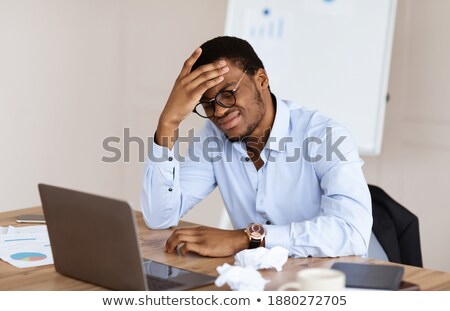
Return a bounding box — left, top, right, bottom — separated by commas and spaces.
264, 126, 372, 257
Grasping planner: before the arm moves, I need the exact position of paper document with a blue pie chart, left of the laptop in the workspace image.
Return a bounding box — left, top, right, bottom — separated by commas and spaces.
0, 225, 53, 268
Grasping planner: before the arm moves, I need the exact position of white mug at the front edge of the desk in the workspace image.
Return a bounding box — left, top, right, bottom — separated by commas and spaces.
278, 268, 345, 291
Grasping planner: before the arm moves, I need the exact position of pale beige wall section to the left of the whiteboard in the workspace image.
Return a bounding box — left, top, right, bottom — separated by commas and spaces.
0, 0, 226, 221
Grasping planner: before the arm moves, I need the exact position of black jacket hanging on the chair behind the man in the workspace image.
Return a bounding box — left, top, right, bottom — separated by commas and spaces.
369, 185, 422, 267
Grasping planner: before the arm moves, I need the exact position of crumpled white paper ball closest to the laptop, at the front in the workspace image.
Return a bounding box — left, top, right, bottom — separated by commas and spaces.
215, 263, 269, 291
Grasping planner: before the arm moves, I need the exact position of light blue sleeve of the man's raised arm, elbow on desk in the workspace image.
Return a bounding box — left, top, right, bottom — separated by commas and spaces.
141, 126, 216, 229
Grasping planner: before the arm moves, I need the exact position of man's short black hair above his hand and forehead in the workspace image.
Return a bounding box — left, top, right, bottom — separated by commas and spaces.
192, 36, 264, 75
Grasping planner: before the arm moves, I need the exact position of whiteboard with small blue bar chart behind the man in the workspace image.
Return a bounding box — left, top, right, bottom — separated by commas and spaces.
225, 0, 397, 155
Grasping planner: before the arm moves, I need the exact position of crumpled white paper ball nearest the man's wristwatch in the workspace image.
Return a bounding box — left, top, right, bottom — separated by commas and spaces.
234, 246, 289, 271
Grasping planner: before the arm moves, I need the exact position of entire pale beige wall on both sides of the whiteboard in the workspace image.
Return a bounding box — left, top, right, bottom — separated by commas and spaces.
0, 0, 450, 271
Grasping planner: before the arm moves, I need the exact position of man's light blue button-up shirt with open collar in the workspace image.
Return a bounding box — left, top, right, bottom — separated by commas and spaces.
141, 100, 372, 257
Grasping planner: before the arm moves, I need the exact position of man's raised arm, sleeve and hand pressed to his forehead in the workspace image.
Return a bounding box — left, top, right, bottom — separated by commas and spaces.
141, 48, 229, 228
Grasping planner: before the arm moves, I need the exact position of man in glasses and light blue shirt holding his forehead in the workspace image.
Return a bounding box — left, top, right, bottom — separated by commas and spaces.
141, 37, 372, 257
